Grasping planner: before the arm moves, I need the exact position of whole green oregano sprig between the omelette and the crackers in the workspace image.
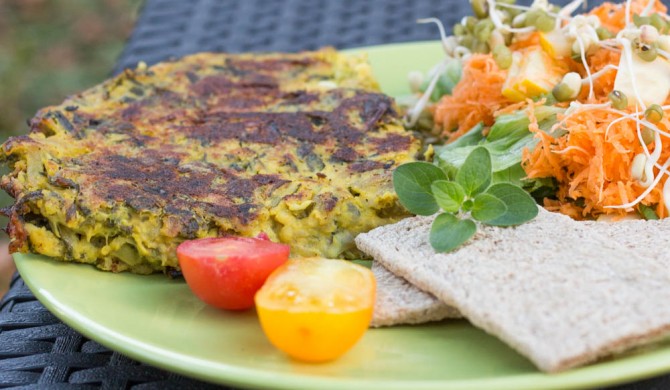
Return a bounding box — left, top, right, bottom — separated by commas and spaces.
393, 147, 538, 252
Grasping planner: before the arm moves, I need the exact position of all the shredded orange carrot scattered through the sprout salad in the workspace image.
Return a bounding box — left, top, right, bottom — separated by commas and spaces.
433, 0, 670, 218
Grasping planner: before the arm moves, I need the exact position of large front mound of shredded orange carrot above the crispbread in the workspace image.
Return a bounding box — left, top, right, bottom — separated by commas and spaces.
523, 102, 670, 217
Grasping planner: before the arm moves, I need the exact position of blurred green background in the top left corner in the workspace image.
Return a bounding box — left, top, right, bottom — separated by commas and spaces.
0, 0, 142, 296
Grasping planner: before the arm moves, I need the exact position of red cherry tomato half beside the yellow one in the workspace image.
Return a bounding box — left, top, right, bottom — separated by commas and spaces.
177, 237, 290, 310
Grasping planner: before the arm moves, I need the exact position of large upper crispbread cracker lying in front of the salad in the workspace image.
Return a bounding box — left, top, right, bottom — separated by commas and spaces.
356, 210, 670, 372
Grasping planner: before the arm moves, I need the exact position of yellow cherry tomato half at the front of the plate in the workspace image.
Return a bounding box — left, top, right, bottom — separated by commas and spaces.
255, 257, 376, 362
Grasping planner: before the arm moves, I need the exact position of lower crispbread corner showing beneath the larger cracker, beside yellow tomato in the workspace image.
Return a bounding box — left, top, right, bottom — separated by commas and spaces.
370, 261, 462, 327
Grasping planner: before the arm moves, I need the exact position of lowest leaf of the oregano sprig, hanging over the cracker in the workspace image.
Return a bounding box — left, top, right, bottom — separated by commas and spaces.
430, 214, 477, 252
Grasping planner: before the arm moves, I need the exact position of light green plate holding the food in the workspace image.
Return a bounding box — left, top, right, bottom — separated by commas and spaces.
14, 42, 670, 389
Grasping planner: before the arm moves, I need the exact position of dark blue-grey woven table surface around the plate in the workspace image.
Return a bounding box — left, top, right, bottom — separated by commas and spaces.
0, 0, 670, 390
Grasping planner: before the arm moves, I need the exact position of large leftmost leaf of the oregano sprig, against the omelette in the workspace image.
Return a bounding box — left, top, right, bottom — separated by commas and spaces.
393, 162, 447, 215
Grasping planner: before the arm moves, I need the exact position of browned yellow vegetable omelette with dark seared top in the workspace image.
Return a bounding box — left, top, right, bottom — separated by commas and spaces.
2, 50, 419, 273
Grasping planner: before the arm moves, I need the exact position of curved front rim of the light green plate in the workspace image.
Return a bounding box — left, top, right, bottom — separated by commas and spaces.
13, 254, 670, 390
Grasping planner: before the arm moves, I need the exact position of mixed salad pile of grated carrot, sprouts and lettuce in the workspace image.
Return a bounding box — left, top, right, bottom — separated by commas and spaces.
408, 0, 670, 219
